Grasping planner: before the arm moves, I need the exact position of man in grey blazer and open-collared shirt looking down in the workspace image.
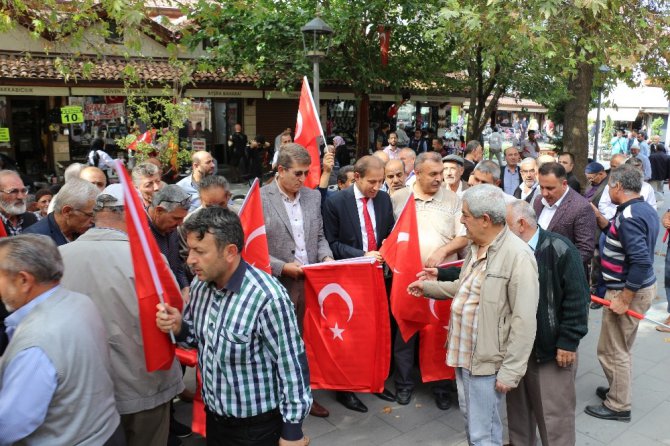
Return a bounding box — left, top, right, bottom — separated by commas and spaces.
261, 143, 333, 417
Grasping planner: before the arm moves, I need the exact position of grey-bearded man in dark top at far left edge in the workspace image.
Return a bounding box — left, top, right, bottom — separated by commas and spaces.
0, 170, 37, 236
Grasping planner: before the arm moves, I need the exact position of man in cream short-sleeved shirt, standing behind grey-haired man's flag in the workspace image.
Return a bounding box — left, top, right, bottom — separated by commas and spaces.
387, 152, 467, 410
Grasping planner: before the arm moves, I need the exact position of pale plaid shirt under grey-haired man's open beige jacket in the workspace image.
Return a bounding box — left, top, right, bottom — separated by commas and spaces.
447, 244, 488, 370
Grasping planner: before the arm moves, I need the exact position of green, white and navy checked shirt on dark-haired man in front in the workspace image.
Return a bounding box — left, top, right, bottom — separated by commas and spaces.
178, 260, 312, 440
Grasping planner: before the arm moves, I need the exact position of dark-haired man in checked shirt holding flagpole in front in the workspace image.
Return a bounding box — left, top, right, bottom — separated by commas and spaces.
156, 207, 312, 446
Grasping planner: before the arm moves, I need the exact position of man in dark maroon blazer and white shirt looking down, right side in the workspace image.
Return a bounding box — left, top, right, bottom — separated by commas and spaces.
533, 163, 596, 271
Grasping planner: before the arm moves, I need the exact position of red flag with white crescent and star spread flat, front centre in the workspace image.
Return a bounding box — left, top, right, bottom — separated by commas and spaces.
303, 258, 391, 393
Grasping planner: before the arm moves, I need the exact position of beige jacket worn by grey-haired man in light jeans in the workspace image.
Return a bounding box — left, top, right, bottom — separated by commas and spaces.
424, 226, 539, 388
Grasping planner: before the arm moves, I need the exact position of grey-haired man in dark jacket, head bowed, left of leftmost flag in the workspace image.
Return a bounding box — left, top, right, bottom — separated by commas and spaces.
24, 179, 100, 246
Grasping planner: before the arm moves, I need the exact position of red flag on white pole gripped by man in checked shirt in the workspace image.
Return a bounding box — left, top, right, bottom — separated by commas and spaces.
115, 161, 182, 372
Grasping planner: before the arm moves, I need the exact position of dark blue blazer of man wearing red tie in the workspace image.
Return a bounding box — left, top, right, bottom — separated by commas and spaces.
323, 186, 395, 260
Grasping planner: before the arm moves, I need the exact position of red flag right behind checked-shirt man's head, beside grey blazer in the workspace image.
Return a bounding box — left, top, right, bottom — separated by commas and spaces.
240, 178, 272, 274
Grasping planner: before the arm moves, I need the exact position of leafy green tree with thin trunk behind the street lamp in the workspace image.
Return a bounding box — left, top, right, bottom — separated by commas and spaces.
184, 0, 454, 154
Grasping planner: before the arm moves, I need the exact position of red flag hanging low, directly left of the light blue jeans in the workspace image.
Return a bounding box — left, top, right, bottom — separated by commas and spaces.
419, 299, 456, 383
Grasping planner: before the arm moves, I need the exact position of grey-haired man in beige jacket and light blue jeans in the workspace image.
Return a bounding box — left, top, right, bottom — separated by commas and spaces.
409, 185, 539, 445
